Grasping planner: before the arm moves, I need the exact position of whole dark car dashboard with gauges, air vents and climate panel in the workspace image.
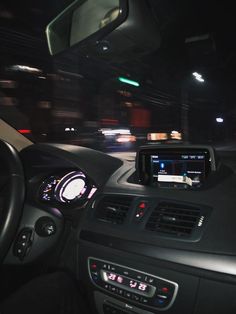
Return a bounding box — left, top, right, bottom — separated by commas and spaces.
6, 144, 236, 314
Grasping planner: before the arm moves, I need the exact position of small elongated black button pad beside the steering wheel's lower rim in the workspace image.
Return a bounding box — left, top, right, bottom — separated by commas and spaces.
13, 228, 33, 260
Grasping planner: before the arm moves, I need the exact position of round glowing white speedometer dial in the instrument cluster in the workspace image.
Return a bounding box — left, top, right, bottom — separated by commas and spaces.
55, 171, 88, 203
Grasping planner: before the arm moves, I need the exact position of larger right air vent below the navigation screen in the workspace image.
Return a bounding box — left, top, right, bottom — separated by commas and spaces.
146, 202, 201, 237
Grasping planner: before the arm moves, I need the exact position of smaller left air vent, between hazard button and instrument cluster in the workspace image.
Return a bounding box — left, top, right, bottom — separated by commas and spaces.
95, 196, 133, 225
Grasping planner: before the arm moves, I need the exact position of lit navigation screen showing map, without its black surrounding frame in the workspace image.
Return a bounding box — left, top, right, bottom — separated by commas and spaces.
151, 153, 206, 187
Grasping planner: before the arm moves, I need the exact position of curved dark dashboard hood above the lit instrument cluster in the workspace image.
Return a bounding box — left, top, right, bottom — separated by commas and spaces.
21, 144, 123, 186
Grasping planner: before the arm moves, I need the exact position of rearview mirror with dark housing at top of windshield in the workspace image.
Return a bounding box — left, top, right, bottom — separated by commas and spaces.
46, 0, 160, 57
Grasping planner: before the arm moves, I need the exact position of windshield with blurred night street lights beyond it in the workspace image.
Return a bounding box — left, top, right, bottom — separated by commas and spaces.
0, 0, 236, 152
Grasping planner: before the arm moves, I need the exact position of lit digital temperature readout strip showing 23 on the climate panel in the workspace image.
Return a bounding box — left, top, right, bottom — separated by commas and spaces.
102, 271, 155, 296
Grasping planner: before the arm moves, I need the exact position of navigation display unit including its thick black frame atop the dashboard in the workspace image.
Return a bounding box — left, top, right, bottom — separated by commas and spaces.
137, 146, 215, 189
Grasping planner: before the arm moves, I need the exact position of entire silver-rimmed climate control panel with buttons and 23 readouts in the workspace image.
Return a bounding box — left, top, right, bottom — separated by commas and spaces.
88, 257, 178, 310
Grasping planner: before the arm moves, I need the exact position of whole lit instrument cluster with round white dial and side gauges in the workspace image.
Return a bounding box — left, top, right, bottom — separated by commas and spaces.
39, 170, 97, 205
